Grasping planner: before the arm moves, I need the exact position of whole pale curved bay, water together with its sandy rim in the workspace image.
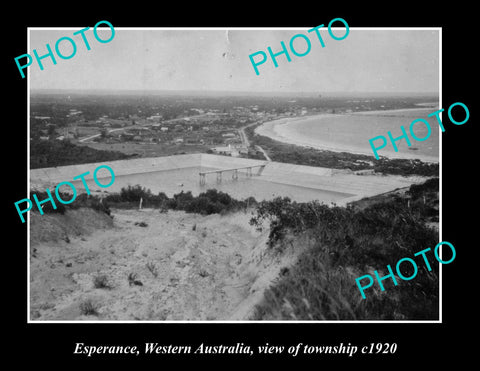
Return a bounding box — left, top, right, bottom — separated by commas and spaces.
255, 107, 440, 162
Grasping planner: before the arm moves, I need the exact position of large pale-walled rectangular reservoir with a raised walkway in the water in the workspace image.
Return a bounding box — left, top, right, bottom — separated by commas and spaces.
30, 154, 424, 205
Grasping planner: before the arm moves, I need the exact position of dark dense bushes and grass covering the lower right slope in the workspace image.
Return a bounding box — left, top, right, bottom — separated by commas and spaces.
251, 179, 438, 320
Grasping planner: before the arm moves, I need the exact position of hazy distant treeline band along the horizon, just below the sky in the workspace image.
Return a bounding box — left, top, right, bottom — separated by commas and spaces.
30, 91, 438, 126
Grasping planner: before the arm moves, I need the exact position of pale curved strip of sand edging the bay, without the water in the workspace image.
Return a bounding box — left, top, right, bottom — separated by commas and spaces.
254, 107, 440, 163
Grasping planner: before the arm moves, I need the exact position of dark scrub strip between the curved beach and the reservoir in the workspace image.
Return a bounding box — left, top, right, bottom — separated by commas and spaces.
245, 127, 439, 176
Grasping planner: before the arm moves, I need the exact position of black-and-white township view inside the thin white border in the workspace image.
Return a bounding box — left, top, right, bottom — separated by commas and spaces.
25, 26, 438, 321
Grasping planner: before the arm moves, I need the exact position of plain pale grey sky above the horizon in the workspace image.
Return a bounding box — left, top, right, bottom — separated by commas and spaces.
28, 26, 440, 93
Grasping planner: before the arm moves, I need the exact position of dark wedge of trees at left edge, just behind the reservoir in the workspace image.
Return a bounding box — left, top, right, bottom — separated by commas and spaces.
30, 139, 135, 169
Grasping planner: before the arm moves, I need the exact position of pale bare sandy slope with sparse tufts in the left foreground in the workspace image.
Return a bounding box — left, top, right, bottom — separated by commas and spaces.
30, 209, 294, 321
